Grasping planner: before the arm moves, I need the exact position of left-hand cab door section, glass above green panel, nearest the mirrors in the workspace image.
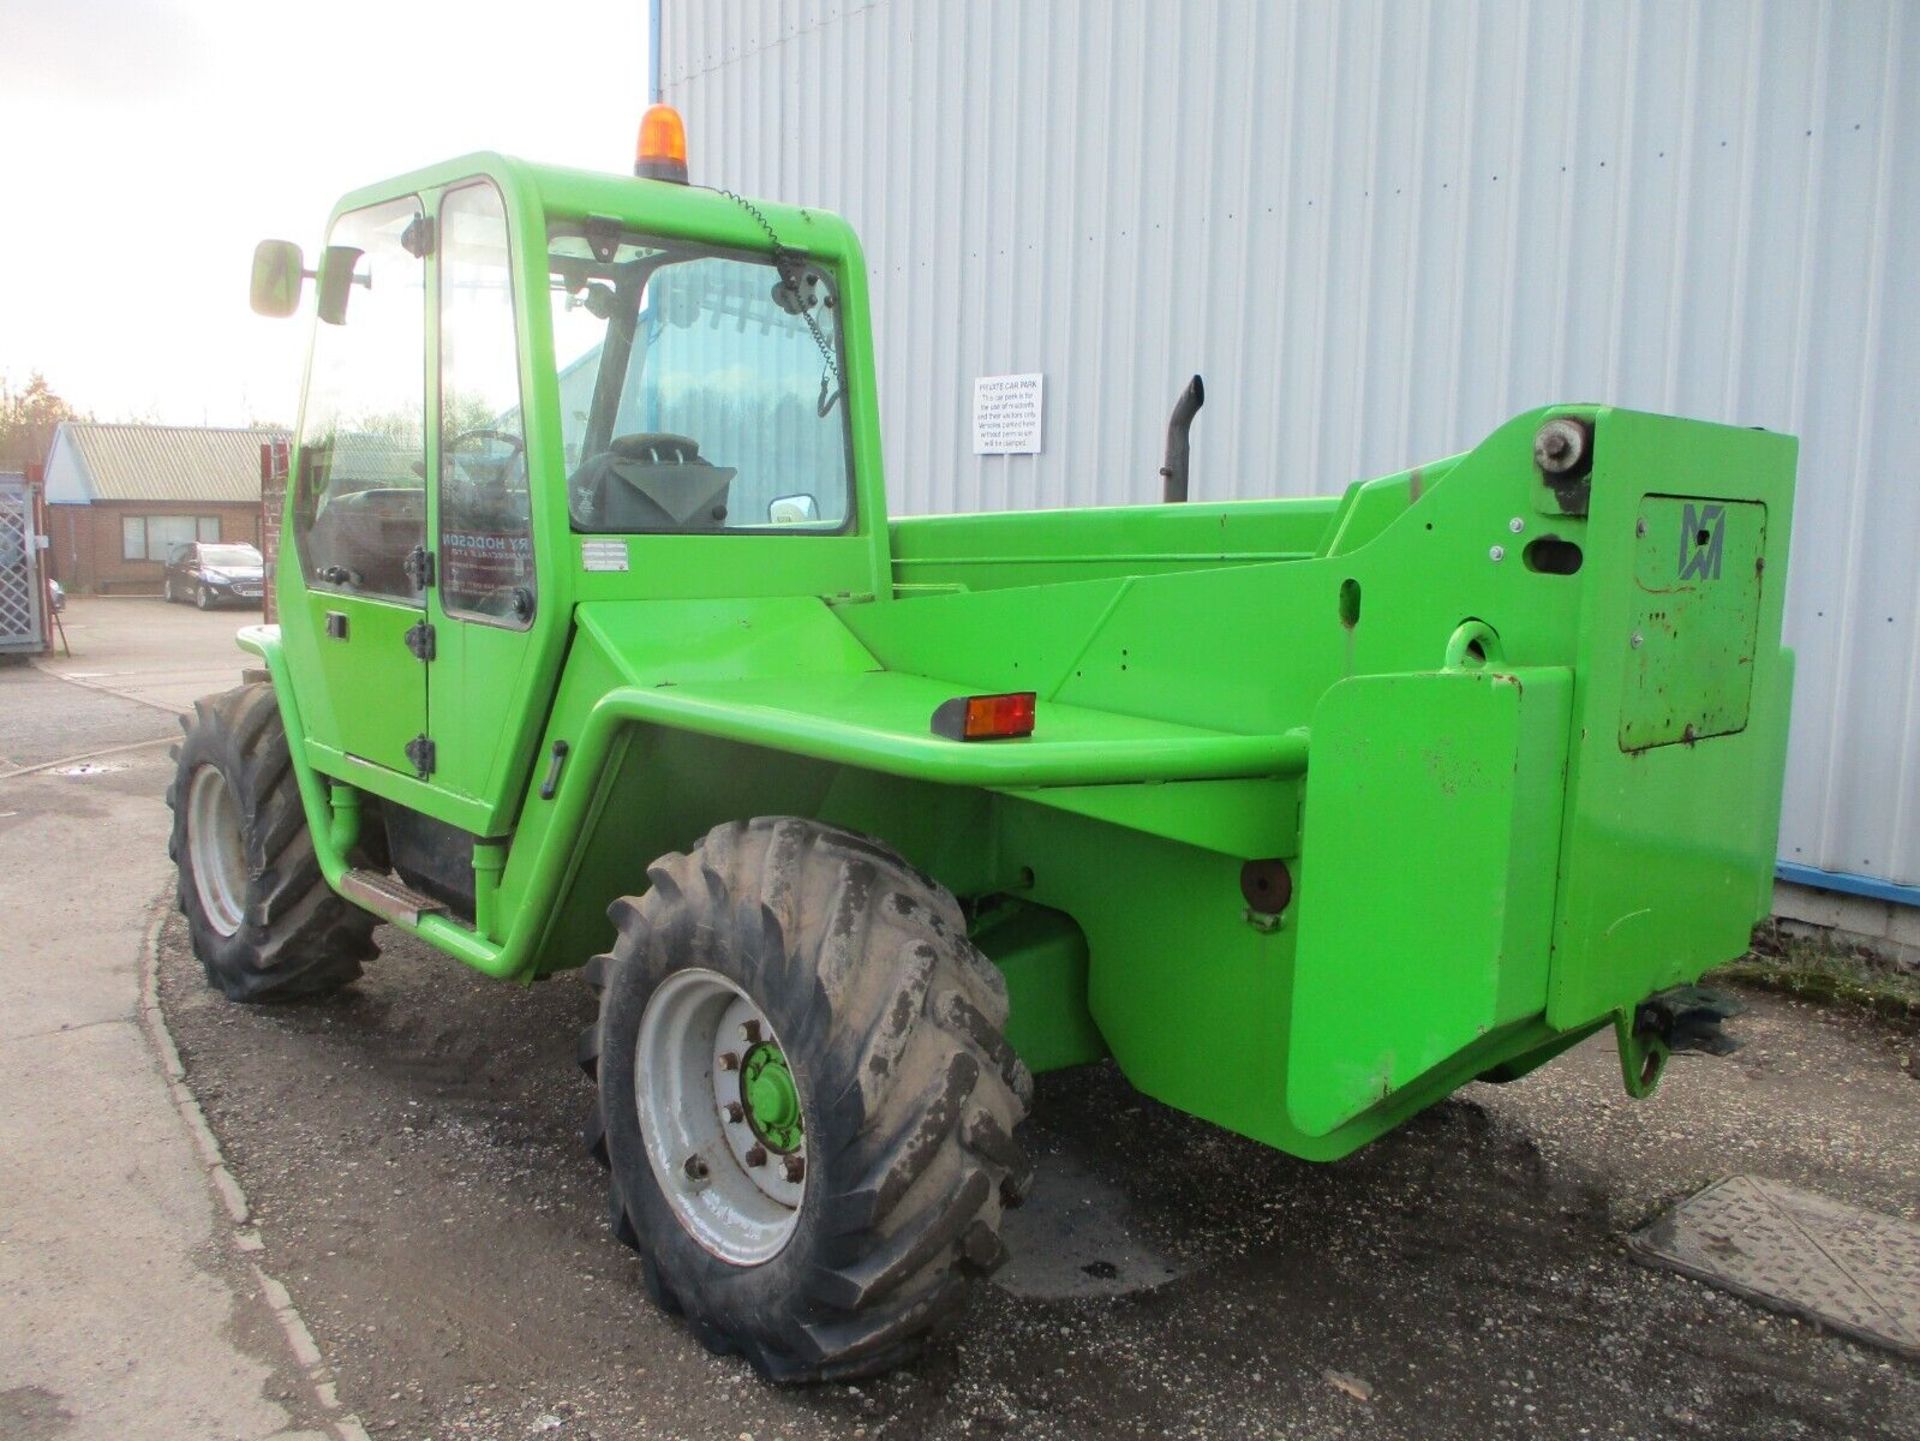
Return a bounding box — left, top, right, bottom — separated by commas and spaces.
276, 196, 432, 777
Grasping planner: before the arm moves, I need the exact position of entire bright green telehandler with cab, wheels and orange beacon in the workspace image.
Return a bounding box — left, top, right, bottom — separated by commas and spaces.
171, 111, 1795, 1380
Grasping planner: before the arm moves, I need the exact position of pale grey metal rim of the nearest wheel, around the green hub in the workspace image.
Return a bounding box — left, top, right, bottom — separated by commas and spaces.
634, 967, 806, 1266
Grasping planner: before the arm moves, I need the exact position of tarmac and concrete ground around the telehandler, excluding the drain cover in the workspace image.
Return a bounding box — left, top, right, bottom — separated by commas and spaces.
0, 602, 1920, 1441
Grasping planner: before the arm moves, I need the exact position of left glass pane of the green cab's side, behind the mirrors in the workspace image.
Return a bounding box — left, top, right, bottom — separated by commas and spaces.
294, 198, 426, 604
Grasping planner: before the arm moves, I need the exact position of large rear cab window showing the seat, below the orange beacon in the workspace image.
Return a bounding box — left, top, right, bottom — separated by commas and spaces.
547, 224, 852, 533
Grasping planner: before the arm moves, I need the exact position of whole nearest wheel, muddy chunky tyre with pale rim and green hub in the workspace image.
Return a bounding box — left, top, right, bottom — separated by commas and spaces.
580, 817, 1033, 1382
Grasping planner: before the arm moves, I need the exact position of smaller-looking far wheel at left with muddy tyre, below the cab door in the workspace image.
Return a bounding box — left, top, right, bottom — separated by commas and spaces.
167, 685, 376, 1002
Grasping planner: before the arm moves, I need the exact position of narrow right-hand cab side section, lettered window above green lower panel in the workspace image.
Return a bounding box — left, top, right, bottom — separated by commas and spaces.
428, 178, 545, 817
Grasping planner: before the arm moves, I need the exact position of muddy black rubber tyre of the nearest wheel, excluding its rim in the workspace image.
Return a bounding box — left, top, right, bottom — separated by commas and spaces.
580, 817, 1033, 1382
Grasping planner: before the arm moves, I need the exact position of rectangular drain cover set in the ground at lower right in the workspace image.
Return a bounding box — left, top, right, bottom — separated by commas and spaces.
1626, 1176, 1920, 1358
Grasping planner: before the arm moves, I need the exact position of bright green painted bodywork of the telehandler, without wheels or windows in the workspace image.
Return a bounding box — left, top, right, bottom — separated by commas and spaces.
242, 155, 1795, 1157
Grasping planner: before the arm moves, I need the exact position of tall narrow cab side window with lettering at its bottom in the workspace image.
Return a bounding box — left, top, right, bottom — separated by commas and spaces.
440, 182, 534, 626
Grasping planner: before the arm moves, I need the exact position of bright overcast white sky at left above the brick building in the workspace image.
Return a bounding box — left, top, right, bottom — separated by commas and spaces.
0, 0, 647, 424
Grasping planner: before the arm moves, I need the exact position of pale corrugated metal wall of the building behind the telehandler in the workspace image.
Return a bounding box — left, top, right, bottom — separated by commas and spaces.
660, 0, 1920, 886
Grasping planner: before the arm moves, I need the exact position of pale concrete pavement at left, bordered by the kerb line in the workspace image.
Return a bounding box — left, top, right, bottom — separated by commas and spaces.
0, 670, 345, 1441
